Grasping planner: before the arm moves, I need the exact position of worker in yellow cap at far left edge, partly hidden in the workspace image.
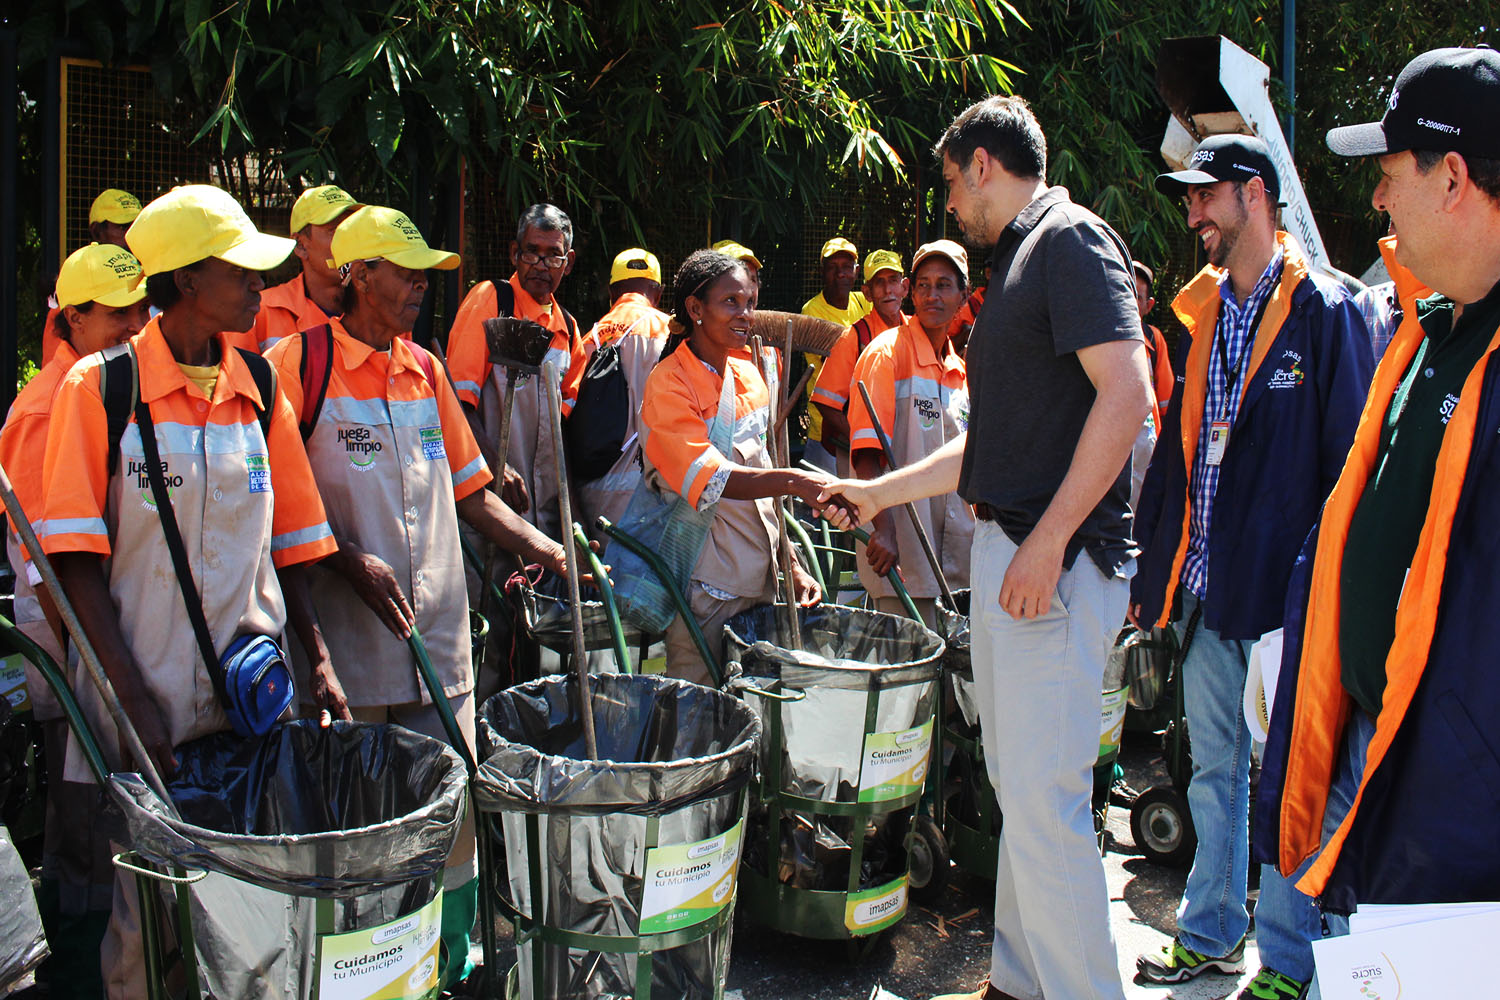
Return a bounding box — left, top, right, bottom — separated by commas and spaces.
0, 243, 147, 994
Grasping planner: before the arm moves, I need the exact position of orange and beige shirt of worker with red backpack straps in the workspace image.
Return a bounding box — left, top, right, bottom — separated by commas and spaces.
267, 319, 491, 708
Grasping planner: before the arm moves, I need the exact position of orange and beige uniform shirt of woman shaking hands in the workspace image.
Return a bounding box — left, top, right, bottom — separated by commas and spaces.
641, 342, 780, 597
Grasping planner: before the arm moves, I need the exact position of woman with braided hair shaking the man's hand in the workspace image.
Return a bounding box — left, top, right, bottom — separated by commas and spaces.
626, 250, 830, 682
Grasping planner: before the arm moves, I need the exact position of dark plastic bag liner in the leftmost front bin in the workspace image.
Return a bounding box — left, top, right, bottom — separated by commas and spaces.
110, 721, 467, 1000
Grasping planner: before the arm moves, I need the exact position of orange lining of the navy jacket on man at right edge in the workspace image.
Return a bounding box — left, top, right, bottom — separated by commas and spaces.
1280, 238, 1500, 895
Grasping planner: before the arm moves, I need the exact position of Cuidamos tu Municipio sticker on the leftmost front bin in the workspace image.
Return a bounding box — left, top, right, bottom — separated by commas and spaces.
318, 892, 443, 1000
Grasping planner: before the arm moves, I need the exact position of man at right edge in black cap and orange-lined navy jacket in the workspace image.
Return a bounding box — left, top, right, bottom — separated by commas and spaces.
1256, 48, 1500, 959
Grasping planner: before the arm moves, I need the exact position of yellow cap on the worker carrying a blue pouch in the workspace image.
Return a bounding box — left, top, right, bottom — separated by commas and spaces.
125, 184, 297, 277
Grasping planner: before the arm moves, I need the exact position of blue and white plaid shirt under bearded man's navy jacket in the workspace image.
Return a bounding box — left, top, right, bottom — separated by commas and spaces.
1182, 247, 1281, 598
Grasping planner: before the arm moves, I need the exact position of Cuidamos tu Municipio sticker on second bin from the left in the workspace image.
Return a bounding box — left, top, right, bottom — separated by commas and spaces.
641, 820, 744, 934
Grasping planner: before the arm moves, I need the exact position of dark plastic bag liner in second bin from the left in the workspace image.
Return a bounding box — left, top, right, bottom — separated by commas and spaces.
474, 675, 761, 1000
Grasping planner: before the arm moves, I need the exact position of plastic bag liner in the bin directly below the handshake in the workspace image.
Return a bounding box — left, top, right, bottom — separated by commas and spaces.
725, 604, 944, 891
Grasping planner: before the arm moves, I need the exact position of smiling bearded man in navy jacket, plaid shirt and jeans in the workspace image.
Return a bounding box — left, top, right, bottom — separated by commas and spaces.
1131, 135, 1374, 1000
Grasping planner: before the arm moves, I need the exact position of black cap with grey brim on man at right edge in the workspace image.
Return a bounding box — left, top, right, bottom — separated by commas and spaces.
1328, 46, 1500, 159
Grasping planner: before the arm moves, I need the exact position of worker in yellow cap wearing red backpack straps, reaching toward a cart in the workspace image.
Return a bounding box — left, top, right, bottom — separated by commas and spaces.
267, 205, 564, 985
